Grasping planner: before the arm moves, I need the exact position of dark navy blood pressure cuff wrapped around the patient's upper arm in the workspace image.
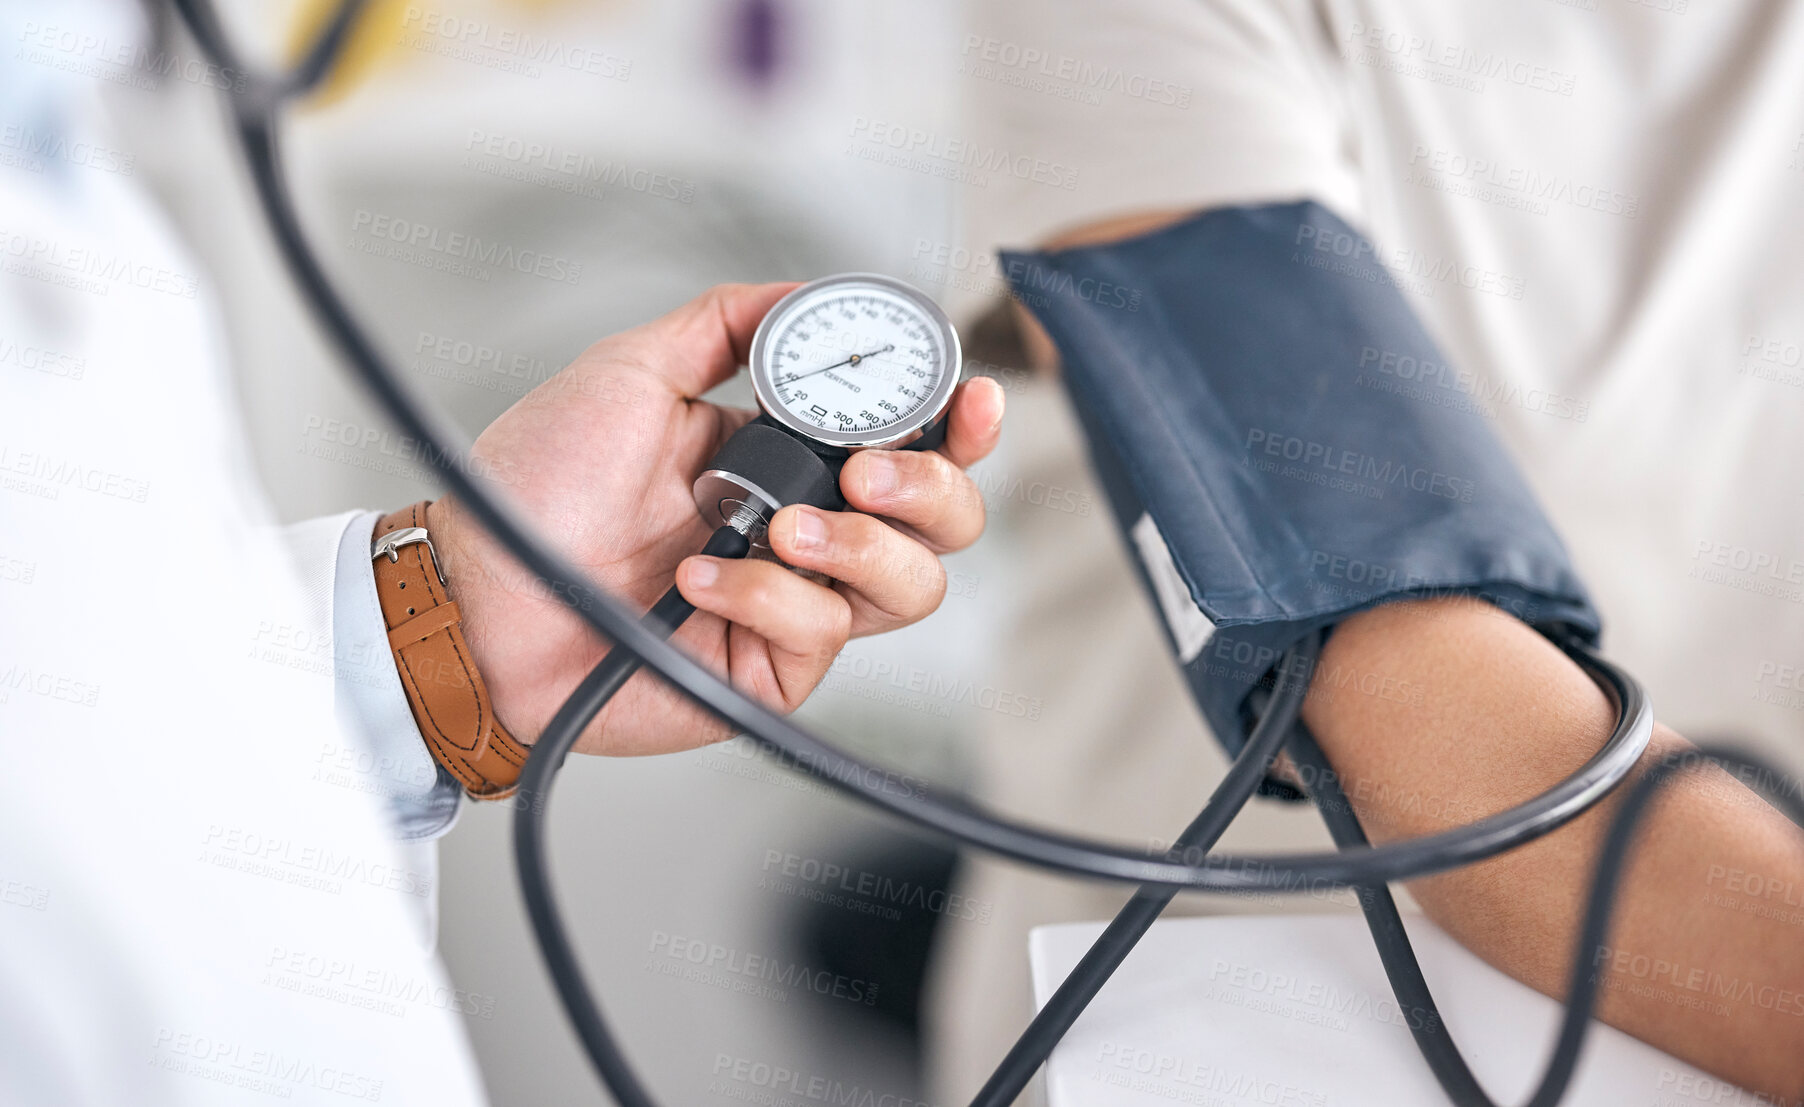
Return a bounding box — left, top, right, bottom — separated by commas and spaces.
1003, 204, 1600, 795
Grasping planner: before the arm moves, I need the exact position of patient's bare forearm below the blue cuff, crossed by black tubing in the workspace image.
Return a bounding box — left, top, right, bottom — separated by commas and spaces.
1304, 600, 1804, 1102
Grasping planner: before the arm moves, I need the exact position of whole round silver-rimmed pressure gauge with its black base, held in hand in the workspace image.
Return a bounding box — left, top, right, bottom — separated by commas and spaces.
695, 272, 963, 537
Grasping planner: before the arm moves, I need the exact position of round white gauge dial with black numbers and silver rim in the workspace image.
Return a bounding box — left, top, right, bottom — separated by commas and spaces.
752, 274, 960, 447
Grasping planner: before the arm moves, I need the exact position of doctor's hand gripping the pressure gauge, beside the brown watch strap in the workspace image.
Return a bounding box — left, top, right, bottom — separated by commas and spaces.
428, 285, 1003, 755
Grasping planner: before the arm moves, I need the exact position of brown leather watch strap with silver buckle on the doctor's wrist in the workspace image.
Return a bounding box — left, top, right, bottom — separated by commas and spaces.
372, 503, 527, 799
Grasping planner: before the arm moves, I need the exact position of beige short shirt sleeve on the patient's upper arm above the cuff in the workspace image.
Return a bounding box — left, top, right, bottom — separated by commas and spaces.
960, 0, 1362, 251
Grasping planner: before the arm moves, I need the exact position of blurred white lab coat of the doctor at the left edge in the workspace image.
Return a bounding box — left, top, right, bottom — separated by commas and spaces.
0, 4, 482, 1107
